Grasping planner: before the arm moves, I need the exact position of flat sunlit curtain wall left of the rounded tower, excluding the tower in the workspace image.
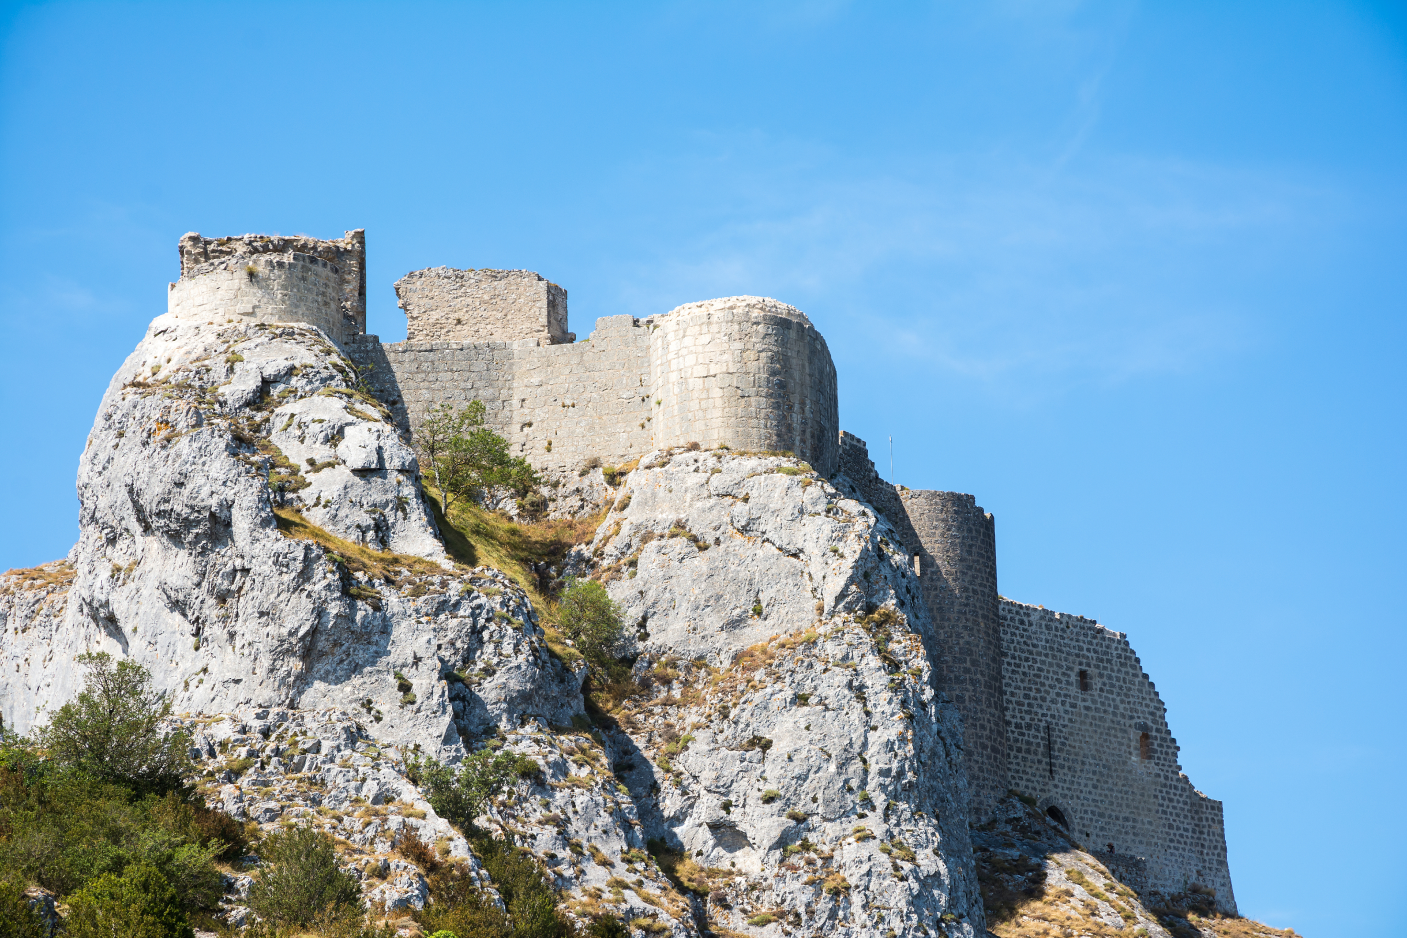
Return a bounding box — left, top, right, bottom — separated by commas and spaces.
350, 316, 654, 471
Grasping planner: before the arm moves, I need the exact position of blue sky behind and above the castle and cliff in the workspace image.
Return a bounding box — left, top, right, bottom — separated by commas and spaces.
0, 0, 1407, 938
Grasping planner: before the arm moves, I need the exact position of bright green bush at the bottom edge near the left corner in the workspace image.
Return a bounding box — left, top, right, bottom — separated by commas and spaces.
65, 863, 196, 938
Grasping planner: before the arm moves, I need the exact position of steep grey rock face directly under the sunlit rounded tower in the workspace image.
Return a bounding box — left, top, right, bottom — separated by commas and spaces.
576, 451, 982, 937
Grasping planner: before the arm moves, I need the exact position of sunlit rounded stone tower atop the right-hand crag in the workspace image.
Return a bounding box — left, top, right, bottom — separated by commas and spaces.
646, 297, 840, 475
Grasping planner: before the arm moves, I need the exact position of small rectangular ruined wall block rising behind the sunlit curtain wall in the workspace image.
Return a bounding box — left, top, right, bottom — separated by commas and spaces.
395, 267, 575, 345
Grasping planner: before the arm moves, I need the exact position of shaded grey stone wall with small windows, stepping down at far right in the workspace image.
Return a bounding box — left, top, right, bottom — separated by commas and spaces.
1000, 599, 1235, 913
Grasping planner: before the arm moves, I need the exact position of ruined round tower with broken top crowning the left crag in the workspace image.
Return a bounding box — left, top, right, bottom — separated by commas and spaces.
166, 229, 366, 345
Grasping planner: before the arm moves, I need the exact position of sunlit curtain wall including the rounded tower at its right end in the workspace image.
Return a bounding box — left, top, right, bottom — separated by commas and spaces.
348, 295, 839, 474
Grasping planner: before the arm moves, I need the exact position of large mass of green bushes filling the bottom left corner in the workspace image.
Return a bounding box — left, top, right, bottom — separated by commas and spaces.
0, 654, 249, 938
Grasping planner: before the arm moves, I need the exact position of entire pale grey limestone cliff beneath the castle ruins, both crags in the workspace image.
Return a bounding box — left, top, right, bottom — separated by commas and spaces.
0, 316, 983, 938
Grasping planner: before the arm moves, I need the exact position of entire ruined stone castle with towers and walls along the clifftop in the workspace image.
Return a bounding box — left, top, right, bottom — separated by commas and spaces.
169, 231, 1235, 911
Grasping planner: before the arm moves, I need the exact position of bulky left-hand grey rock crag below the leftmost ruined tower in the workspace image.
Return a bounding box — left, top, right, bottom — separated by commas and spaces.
0, 316, 581, 758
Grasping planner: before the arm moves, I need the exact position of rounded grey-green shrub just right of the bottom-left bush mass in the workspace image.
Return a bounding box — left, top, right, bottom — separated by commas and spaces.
249, 827, 362, 927
